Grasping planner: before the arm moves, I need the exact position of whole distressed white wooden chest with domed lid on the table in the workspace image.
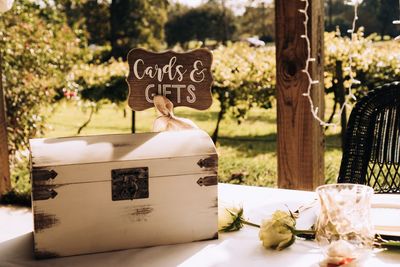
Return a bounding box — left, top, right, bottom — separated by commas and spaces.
30, 130, 218, 258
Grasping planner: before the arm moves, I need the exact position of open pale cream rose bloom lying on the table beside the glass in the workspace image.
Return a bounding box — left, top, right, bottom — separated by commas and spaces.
259, 210, 296, 250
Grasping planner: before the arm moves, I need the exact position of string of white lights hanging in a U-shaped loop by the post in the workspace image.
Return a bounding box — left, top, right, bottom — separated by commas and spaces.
299, 0, 360, 128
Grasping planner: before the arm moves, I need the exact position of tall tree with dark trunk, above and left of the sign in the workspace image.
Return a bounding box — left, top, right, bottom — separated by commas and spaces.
55, 0, 169, 58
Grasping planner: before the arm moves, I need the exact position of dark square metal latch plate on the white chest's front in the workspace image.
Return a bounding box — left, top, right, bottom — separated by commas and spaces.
111, 167, 149, 201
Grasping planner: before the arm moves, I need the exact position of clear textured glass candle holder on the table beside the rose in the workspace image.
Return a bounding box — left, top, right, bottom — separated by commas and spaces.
315, 184, 374, 259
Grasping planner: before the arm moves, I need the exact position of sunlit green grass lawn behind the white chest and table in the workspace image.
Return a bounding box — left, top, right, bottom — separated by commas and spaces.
7, 101, 341, 203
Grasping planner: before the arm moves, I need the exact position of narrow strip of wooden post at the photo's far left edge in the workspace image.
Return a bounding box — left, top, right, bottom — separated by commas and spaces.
0, 53, 11, 195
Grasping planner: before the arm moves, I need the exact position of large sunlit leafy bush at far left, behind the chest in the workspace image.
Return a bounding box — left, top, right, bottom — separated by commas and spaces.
0, 0, 83, 154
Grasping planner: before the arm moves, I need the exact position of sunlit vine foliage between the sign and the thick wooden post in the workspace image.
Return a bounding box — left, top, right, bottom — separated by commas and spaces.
212, 42, 276, 142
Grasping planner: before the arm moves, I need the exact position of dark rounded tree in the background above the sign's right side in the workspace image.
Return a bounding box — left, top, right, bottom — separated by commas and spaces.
165, 3, 236, 46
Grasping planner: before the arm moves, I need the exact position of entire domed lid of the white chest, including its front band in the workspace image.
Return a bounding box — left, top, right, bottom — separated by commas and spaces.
30, 130, 218, 188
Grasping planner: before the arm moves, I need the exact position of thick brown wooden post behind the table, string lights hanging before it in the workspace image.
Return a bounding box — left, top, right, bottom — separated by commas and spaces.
275, 0, 324, 190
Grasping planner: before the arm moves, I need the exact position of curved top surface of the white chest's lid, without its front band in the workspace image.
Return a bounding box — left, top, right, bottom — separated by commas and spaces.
30, 130, 216, 167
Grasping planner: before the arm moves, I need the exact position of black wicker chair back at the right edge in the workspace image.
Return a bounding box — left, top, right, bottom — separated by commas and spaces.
338, 82, 400, 193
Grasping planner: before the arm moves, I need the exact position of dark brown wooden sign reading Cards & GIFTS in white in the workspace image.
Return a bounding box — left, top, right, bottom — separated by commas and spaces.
127, 48, 213, 111
